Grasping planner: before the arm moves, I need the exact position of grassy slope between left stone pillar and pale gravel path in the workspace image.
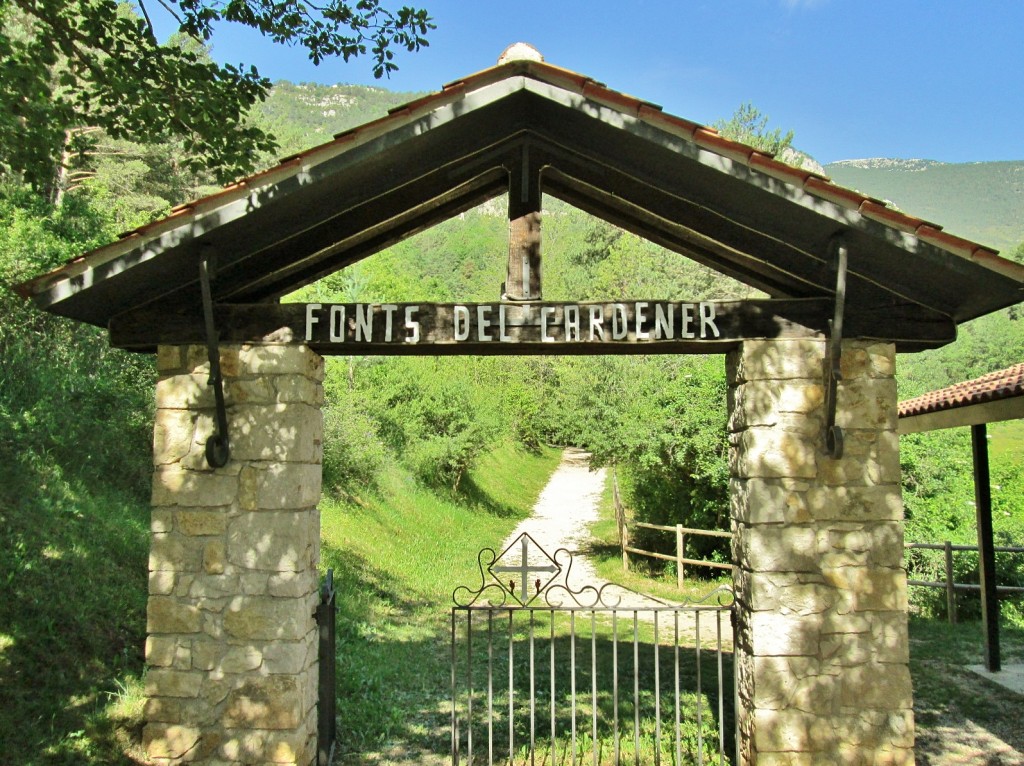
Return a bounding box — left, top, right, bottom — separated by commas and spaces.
322, 446, 560, 763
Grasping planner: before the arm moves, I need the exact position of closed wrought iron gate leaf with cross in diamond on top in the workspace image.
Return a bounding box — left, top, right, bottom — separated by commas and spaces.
451, 534, 734, 766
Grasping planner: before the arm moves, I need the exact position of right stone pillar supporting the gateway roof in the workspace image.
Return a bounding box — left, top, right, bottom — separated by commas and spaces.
728, 340, 913, 766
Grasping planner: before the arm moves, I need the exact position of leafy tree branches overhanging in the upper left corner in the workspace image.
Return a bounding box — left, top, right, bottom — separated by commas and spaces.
0, 0, 434, 189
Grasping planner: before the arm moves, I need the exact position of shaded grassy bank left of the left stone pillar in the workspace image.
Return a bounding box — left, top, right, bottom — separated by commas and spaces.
0, 462, 148, 766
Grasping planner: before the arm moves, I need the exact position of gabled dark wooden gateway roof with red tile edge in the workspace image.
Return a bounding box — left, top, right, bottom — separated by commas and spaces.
12, 44, 1024, 350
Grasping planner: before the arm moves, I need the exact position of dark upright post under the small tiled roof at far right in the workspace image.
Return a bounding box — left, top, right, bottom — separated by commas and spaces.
971, 423, 1000, 673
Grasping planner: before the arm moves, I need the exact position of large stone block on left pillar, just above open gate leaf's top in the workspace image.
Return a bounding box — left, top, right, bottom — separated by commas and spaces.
227, 510, 319, 571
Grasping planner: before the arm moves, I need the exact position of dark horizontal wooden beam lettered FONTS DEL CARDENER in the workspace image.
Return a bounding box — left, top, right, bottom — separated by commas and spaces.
110, 298, 949, 355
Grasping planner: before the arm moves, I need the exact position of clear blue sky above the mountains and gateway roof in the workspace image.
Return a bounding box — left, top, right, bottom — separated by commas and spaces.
151, 0, 1024, 163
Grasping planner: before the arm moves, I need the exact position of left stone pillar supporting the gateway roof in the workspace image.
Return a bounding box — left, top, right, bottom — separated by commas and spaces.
143, 345, 324, 766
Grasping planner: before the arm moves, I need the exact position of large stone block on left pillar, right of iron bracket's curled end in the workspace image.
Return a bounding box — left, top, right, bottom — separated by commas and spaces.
228, 403, 324, 463
